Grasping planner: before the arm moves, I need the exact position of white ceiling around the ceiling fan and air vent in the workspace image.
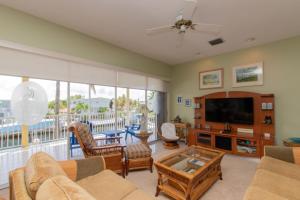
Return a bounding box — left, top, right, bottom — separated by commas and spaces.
0, 0, 300, 64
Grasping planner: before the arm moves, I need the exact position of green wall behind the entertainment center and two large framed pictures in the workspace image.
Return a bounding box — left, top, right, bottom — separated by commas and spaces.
170, 37, 300, 144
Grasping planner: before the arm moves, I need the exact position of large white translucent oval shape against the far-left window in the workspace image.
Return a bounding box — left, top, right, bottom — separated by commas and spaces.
11, 81, 48, 125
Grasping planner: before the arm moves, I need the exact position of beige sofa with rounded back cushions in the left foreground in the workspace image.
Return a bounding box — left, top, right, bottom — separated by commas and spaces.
9, 152, 154, 200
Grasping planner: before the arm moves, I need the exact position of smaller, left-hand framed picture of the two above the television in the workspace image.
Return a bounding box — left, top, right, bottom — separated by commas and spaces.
199, 69, 223, 89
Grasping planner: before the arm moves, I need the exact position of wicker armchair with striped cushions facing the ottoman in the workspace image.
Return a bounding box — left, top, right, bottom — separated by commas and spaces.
69, 122, 125, 177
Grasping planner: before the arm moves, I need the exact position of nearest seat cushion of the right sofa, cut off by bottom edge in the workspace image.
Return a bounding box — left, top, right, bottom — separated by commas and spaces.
243, 186, 288, 200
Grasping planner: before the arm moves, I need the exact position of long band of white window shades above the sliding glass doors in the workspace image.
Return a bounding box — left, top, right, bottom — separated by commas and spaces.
0, 47, 167, 92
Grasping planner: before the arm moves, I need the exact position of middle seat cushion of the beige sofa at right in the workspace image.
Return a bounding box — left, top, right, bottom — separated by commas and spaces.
252, 169, 300, 199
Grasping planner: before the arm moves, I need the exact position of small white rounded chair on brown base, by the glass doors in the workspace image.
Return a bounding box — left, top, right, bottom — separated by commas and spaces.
159, 123, 180, 149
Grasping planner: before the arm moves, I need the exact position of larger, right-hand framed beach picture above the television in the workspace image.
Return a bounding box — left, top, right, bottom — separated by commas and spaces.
232, 62, 264, 87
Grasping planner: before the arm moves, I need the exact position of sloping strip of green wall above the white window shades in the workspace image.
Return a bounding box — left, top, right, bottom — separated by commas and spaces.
0, 6, 171, 77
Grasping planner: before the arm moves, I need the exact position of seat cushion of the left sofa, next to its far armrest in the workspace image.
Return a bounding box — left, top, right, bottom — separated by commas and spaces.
77, 170, 137, 200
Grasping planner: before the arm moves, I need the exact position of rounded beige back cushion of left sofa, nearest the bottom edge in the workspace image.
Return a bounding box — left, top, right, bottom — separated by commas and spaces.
36, 176, 95, 200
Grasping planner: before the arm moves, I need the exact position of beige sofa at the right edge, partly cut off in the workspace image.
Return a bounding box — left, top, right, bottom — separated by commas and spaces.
244, 146, 300, 200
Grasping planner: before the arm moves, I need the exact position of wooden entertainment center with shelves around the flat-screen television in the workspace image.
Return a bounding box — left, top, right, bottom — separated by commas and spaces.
188, 91, 275, 157
